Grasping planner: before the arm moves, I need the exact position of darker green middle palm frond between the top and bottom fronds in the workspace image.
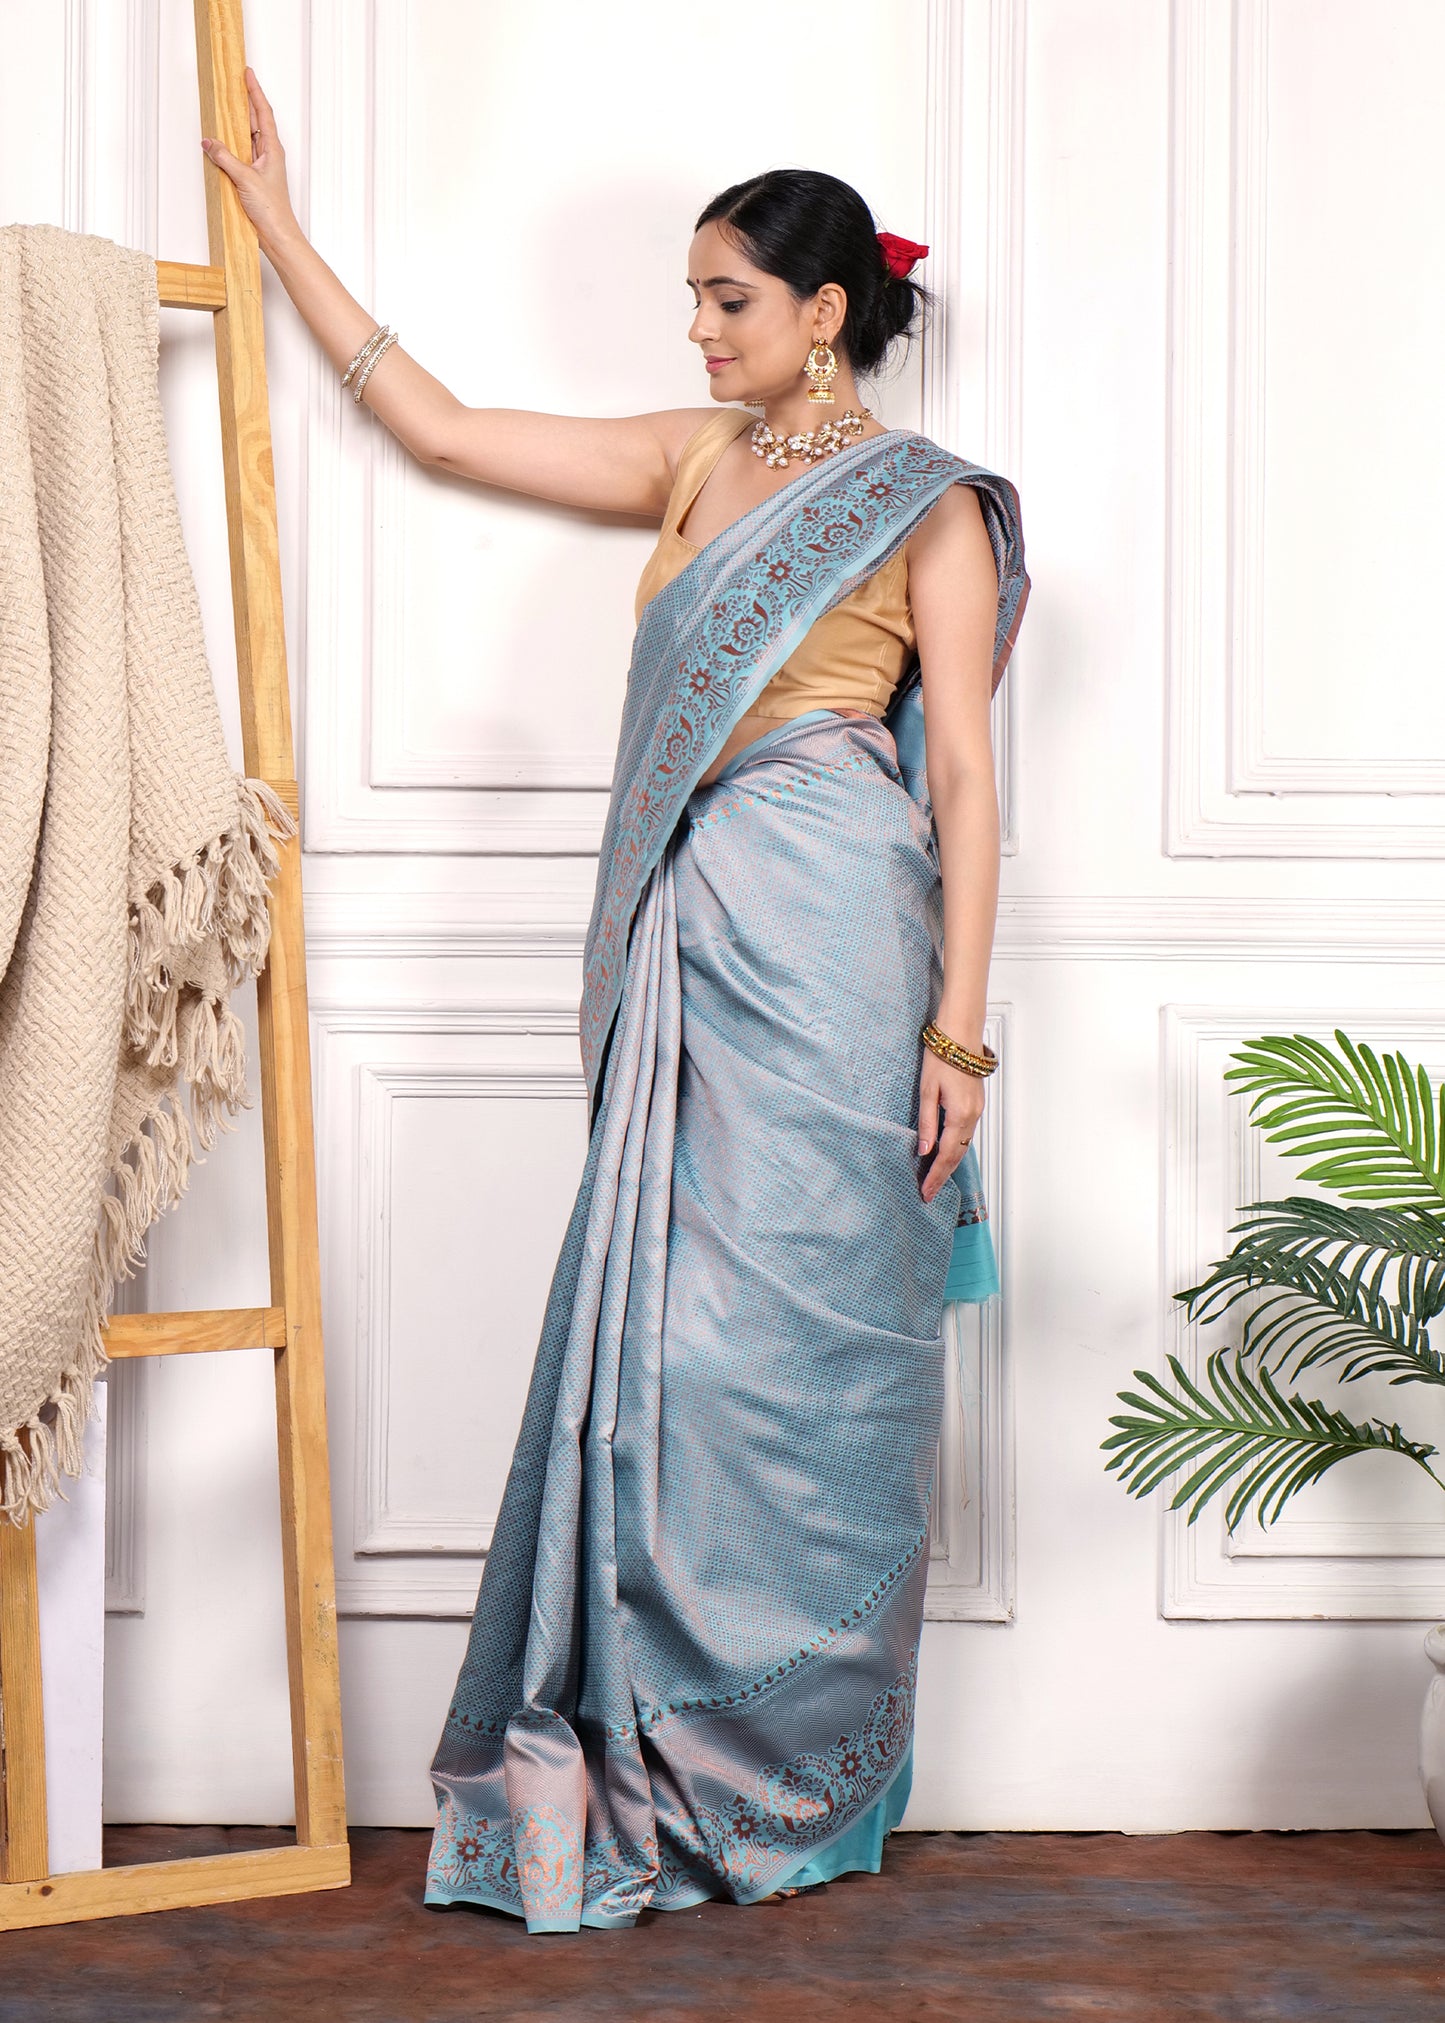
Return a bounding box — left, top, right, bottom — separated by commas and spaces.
1176, 1244, 1445, 1384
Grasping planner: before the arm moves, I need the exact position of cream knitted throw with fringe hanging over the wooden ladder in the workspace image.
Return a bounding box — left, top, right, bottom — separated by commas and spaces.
0, 225, 295, 1523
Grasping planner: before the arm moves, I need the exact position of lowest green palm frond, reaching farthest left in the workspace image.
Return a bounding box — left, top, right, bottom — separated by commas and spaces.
1101, 1349, 1445, 1531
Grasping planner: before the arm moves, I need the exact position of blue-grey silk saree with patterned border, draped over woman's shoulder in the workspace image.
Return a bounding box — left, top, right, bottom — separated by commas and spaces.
427, 431, 1028, 1932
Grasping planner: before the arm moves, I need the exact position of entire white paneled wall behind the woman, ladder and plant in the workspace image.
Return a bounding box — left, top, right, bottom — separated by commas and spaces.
0, 0, 1445, 1829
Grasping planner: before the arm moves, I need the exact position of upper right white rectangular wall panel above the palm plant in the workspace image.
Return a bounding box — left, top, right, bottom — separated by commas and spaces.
1170, 0, 1445, 858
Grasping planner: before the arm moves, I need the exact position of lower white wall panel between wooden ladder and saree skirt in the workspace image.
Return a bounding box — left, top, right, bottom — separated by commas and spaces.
316, 999, 587, 1616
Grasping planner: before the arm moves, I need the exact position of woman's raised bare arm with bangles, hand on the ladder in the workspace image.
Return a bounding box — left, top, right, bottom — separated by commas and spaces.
200, 69, 714, 518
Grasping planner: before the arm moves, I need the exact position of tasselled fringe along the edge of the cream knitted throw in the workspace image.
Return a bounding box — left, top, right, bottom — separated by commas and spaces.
0, 779, 295, 1525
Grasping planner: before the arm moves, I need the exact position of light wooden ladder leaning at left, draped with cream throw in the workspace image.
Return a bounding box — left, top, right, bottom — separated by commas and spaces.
0, 0, 350, 1930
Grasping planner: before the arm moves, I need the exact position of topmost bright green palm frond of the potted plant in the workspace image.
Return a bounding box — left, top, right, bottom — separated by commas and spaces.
1224, 1032, 1445, 1206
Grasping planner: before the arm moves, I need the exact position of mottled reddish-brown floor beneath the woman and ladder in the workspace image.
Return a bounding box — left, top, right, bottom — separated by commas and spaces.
11, 1827, 1445, 2023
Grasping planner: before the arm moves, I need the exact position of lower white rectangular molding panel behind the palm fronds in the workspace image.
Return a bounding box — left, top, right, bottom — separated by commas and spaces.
1158, 1005, 1445, 1622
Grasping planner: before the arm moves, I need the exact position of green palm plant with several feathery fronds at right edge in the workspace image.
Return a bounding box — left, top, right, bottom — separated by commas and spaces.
1103, 1032, 1445, 1529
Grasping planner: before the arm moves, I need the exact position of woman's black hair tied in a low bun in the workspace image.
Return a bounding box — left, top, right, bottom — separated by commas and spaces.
694, 168, 929, 374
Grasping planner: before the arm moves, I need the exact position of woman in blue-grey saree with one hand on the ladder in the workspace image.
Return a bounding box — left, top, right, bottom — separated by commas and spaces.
202, 73, 1028, 1932
